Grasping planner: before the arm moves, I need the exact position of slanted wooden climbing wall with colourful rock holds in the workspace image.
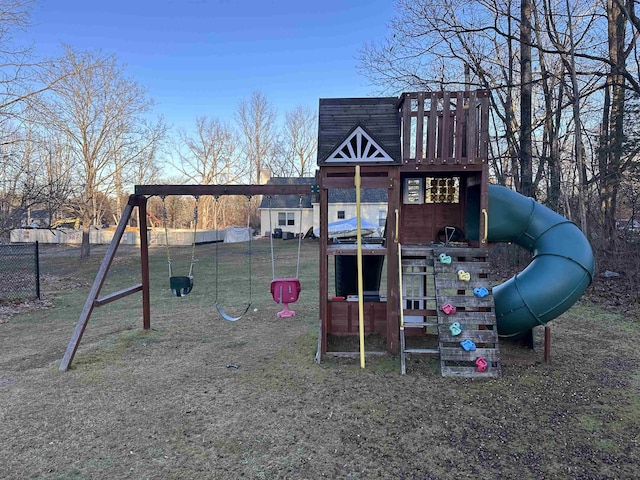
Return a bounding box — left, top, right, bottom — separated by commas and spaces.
434, 247, 502, 377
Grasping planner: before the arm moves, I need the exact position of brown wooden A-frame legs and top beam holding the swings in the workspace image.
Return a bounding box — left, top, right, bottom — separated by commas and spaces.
59, 185, 318, 372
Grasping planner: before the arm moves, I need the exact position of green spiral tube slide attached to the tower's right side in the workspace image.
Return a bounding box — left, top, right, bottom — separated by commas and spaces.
487, 185, 595, 339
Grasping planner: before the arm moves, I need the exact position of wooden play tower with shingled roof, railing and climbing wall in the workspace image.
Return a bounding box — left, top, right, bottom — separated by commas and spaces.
317, 90, 501, 376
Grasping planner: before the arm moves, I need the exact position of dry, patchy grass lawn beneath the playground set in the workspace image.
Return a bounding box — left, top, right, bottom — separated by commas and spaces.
0, 240, 640, 480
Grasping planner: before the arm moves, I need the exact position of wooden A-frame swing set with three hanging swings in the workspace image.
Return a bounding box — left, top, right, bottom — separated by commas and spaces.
60, 184, 319, 372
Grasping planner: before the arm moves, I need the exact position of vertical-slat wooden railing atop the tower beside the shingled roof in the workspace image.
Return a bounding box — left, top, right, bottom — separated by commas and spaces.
399, 90, 489, 165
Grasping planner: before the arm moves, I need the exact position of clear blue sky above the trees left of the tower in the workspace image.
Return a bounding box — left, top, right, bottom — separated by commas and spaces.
26, 0, 394, 129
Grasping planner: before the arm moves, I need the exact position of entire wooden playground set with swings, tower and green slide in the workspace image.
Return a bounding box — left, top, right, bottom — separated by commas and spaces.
60, 90, 595, 377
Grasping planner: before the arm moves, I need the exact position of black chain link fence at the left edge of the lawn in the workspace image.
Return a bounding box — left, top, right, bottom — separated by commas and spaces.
0, 242, 40, 301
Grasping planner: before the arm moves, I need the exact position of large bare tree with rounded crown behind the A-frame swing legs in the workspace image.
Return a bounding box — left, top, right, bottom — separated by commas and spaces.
39, 46, 159, 257
